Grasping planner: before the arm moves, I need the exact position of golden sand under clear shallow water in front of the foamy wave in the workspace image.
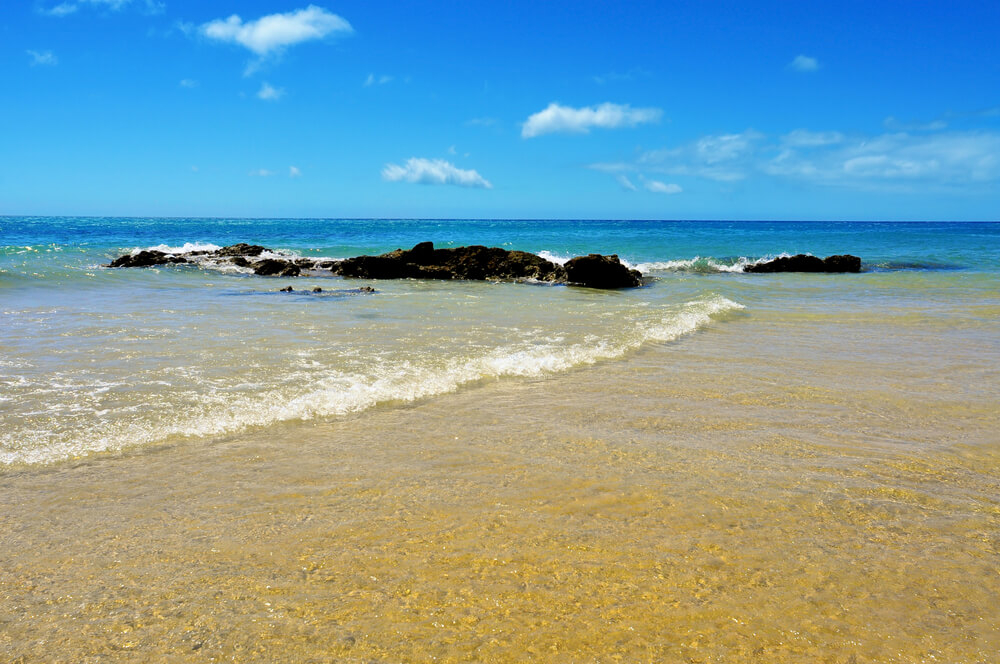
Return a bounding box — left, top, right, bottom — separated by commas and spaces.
0, 316, 1000, 663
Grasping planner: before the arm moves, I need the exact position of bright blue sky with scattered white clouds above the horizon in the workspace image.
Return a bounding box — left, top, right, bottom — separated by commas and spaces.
0, 0, 1000, 221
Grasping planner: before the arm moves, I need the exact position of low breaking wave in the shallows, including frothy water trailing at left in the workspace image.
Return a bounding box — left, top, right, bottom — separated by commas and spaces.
0, 296, 743, 465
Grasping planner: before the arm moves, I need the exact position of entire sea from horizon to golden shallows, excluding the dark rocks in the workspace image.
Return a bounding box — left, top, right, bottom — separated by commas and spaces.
0, 217, 1000, 662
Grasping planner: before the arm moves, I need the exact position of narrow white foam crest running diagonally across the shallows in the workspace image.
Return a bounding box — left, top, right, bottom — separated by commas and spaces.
0, 296, 744, 465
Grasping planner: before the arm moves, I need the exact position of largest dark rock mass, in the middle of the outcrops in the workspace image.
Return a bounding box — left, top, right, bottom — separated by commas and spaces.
331, 242, 641, 288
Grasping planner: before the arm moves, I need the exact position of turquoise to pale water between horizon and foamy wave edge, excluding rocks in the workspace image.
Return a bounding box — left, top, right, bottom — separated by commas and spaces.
0, 217, 1000, 466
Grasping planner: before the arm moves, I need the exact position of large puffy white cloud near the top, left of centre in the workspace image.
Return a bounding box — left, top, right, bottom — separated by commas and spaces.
199, 5, 354, 57
